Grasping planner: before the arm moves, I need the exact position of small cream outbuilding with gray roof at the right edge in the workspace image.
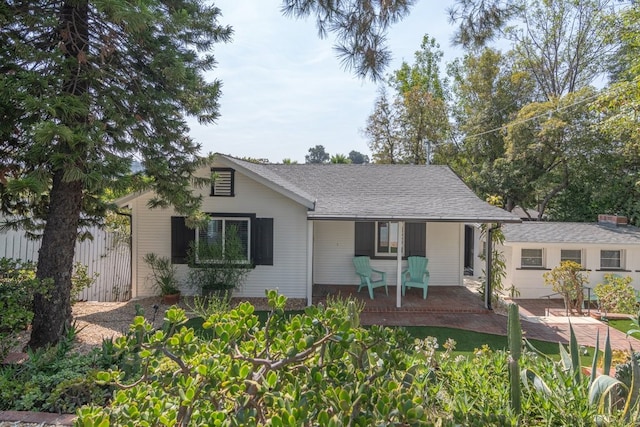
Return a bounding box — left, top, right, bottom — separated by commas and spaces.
502, 215, 640, 298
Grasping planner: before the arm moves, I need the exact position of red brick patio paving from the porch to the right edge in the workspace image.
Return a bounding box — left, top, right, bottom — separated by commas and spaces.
313, 285, 640, 350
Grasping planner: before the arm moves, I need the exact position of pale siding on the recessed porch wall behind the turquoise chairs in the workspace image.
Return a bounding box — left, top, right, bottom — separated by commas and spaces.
313, 221, 464, 286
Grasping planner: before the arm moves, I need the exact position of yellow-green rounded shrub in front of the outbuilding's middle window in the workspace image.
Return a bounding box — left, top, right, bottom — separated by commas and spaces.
542, 261, 589, 315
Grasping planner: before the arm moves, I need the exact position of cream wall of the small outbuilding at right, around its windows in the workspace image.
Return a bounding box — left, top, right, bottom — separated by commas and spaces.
501, 243, 640, 299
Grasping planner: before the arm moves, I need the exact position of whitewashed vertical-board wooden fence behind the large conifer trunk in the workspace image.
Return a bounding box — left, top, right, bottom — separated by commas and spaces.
0, 227, 131, 302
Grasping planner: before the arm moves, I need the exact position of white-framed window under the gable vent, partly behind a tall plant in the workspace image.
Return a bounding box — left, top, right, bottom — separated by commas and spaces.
196, 217, 251, 261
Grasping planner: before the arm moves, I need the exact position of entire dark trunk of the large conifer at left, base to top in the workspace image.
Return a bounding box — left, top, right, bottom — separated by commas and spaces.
28, 0, 89, 348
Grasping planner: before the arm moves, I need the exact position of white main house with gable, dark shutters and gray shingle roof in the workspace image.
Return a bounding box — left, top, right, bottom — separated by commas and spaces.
119, 155, 519, 306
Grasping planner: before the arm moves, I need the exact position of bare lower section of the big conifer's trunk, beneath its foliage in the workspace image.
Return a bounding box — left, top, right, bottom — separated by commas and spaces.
29, 171, 82, 348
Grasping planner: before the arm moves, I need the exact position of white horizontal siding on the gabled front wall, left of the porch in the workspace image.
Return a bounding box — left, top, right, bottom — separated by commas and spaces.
133, 162, 307, 298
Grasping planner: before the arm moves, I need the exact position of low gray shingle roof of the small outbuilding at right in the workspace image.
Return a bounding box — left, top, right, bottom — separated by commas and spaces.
503, 221, 640, 245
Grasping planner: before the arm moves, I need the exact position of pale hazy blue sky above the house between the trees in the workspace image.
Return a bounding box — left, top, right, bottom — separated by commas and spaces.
189, 0, 461, 163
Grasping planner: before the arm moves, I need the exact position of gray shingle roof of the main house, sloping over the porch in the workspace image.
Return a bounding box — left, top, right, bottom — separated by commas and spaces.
220, 158, 519, 222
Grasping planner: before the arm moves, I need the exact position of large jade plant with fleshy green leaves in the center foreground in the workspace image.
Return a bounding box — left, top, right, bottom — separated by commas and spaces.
78, 291, 447, 425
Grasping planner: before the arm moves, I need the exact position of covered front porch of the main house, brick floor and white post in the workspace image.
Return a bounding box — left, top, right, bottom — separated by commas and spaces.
306, 219, 500, 313
